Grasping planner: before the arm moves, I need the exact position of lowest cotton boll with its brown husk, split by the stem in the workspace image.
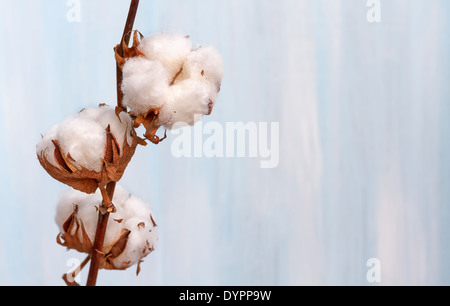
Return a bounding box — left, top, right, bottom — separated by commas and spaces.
55, 186, 158, 271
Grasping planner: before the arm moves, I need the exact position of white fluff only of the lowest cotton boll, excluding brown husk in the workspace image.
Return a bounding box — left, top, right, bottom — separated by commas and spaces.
55, 185, 158, 269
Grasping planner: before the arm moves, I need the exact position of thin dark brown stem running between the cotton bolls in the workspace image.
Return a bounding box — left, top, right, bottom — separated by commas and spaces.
86, 0, 139, 286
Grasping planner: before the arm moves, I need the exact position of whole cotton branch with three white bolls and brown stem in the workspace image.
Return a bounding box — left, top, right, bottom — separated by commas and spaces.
36, 0, 224, 286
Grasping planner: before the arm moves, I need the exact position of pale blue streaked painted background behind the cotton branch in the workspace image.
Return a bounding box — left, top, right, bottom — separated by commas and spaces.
0, 0, 450, 285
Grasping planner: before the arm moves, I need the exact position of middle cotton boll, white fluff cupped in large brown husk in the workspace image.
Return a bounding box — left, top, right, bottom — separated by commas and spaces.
37, 106, 138, 194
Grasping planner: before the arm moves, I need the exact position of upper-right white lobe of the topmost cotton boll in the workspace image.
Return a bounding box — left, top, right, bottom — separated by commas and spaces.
179, 47, 224, 89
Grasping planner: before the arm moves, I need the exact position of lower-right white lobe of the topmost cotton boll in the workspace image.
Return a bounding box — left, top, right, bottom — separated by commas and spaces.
159, 79, 217, 129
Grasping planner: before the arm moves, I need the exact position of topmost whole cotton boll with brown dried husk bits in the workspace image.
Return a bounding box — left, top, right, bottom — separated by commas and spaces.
116, 33, 224, 143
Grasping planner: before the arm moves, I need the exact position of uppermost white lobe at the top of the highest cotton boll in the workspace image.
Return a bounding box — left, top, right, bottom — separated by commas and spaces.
138, 33, 192, 77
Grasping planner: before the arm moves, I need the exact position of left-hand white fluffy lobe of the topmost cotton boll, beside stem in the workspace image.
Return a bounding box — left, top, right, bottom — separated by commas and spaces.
122, 57, 171, 115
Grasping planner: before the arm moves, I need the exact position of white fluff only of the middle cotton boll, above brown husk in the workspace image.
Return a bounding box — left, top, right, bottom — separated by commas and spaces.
36, 106, 132, 172
